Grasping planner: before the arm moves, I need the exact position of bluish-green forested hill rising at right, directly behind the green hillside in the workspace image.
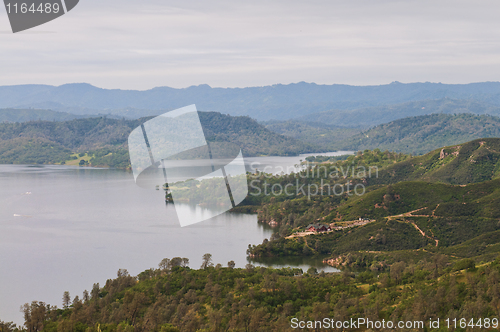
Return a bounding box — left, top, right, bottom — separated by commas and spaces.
330, 114, 500, 154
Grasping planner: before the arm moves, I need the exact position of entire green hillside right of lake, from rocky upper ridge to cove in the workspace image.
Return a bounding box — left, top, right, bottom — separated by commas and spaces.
250, 138, 500, 259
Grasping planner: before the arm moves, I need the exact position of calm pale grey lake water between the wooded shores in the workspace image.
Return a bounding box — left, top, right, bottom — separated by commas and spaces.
0, 153, 345, 324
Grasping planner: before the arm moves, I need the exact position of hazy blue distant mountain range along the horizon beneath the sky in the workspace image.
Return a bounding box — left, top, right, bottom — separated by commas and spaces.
0, 82, 500, 121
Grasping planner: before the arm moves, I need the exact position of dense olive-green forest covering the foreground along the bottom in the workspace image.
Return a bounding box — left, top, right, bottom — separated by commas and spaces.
0, 253, 500, 332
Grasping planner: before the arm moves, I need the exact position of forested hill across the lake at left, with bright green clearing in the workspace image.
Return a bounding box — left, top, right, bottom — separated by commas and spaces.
0, 112, 318, 167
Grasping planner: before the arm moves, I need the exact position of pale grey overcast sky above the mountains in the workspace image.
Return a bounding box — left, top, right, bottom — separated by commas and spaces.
0, 0, 500, 90
